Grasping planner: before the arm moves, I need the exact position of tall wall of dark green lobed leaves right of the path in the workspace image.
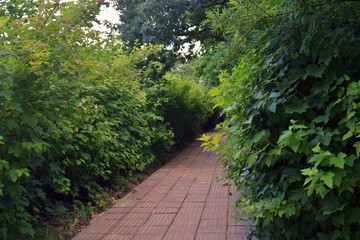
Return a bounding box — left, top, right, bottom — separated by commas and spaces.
201, 1, 360, 240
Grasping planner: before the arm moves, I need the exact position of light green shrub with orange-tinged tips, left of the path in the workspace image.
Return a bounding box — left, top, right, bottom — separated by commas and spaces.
0, 1, 172, 239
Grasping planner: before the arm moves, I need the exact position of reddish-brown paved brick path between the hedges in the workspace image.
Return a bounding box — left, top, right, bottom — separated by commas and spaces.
74, 133, 252, 240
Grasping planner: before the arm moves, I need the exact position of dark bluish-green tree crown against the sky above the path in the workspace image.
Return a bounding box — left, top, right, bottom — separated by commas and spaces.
115, 0, 228, 53
